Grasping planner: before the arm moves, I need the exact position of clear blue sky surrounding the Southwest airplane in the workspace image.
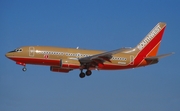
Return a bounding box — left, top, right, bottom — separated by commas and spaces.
0, 0, 180, 111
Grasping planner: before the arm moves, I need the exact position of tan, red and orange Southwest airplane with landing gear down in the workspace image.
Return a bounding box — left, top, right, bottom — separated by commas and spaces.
5, 22, 173, 78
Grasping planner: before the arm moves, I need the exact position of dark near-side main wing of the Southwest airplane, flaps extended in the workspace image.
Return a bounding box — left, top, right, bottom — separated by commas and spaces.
79, 49, 123, 64
